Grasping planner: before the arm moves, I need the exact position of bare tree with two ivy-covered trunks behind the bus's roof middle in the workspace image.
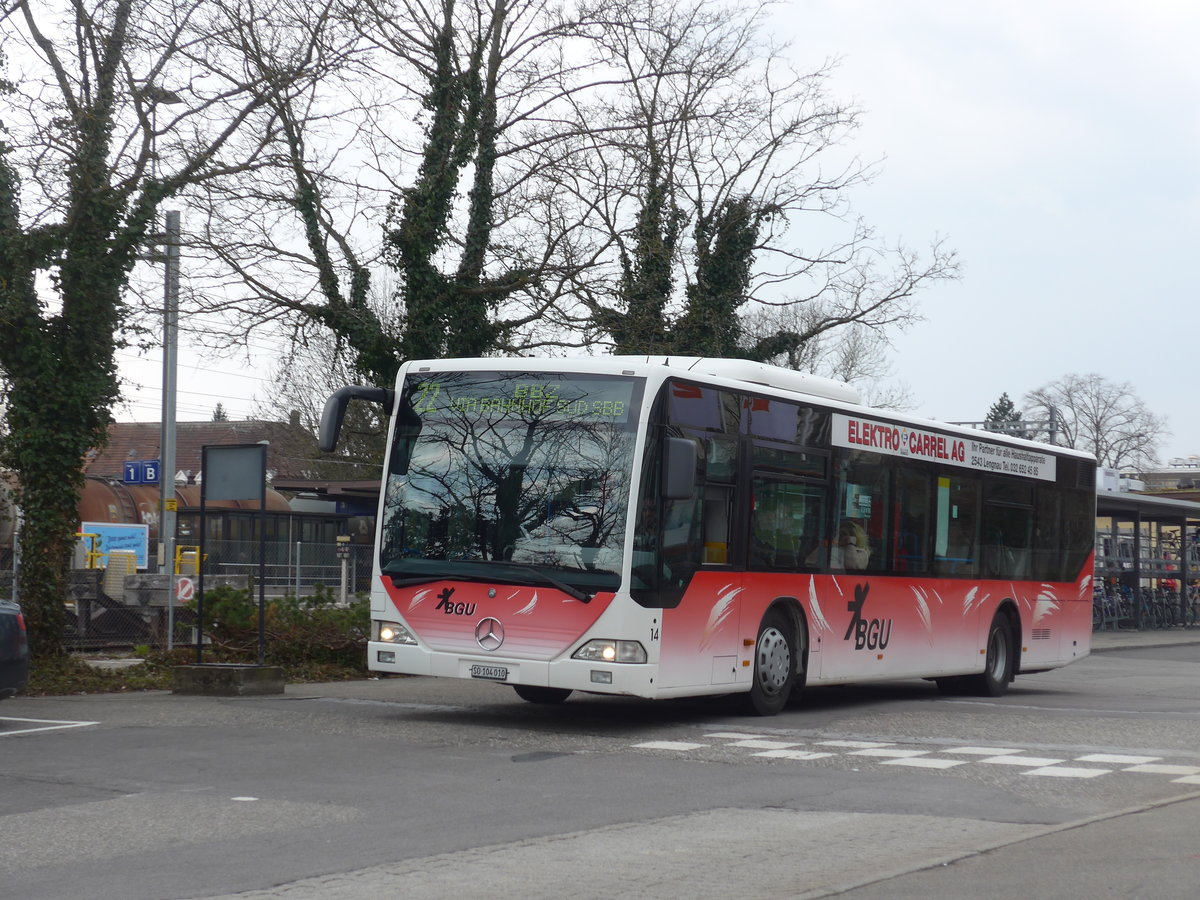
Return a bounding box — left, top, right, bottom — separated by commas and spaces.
564, 0, 956, 359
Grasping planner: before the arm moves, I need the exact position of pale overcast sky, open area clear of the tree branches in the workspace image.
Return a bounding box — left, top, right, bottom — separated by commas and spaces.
120, 0, 1200, 460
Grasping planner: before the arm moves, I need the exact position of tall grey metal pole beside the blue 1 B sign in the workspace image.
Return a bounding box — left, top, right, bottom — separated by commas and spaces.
158, 210, 180, 650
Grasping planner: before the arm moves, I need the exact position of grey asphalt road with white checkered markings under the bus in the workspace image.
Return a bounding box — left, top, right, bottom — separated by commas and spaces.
0, 643, 1200, 900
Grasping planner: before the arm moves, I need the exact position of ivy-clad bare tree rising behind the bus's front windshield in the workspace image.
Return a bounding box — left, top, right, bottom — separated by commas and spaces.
183, 0, 638, 383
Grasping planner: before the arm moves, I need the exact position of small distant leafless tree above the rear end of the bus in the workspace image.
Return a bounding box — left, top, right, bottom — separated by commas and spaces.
1024, 373, 1170, 469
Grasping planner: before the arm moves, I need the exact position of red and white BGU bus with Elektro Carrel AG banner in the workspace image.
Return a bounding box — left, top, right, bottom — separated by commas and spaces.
322, 356, 1096, 715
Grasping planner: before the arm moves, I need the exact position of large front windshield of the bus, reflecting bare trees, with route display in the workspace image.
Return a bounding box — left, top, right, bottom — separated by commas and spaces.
379, 372, 642, 592
